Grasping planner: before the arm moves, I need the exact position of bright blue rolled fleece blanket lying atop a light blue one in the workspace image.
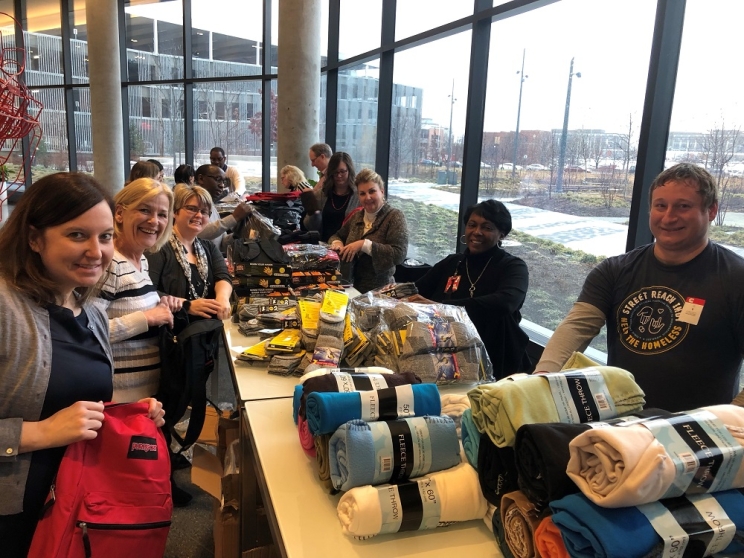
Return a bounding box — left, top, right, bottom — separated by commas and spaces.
305, 384, 442, 436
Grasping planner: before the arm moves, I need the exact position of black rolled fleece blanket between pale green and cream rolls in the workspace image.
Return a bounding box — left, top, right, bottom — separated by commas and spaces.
514, 409, 671, 508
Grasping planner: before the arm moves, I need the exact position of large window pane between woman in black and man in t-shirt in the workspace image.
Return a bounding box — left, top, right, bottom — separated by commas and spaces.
478, 0, 655, 348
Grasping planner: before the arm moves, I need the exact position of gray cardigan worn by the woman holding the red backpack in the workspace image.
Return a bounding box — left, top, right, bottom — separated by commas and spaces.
0, 278, 114, 515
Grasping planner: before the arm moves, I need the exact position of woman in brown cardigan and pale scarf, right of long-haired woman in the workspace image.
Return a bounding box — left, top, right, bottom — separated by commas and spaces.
328, 169, 408, 293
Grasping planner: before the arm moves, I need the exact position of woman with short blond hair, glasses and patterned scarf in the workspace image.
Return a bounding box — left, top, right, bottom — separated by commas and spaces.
147, 184, 232, 320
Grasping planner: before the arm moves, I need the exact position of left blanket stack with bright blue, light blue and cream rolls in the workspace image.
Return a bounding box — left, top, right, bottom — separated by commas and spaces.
294, 368, 486, 539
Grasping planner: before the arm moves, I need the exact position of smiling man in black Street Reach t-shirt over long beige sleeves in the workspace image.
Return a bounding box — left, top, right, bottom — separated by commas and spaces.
536, 163, 744, 411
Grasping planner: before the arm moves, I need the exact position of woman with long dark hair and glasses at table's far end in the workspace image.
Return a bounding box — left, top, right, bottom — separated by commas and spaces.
305, 151, 359, 242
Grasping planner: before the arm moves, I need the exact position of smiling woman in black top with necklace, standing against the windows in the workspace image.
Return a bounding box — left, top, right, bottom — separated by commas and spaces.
410, 200, 532, 379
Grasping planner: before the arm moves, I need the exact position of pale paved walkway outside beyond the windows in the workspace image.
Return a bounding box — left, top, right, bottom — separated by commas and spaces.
389, 182, 744, 257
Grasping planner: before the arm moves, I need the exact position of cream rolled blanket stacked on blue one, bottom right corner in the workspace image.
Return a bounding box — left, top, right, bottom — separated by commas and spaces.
546, 405, 744, 558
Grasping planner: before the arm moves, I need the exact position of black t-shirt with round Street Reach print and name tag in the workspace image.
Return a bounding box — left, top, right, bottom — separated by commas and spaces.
578, 242, 744, 411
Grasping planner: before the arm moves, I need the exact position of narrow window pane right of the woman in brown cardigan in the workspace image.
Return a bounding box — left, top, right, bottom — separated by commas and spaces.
388, 30, 471, 264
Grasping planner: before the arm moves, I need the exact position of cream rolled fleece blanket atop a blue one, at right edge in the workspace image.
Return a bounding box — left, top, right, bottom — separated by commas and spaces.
566, 405, 744, 508
